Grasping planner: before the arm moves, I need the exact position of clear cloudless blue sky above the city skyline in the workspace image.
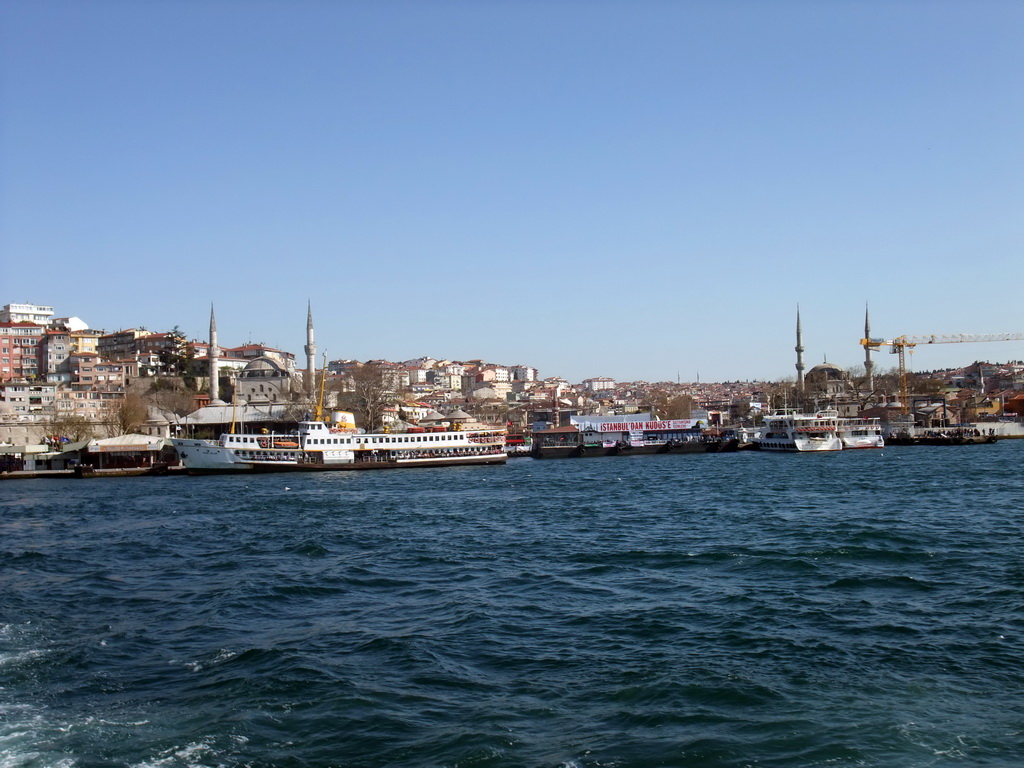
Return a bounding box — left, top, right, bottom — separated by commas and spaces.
0, 0, 1024, 381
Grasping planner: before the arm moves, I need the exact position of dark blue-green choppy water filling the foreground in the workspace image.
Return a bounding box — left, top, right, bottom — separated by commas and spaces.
0, 441, 1024, 768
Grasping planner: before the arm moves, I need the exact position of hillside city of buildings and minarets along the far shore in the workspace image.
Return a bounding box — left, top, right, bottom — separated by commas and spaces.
0, 303, 1024, 443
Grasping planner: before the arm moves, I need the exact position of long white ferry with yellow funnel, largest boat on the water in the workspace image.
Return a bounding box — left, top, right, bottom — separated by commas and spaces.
171, 421, 508, 474
